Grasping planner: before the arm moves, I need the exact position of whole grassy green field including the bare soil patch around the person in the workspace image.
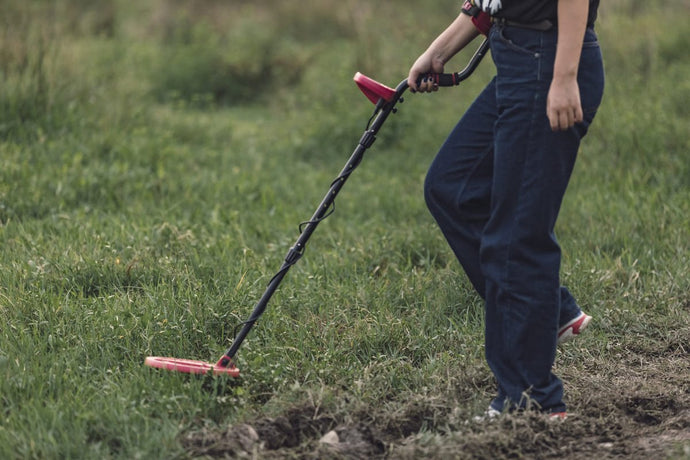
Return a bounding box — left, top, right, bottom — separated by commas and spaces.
0, 0, 690, 459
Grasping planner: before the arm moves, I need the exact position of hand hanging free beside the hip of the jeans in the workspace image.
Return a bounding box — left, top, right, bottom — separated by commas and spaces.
546, 76, 583, 131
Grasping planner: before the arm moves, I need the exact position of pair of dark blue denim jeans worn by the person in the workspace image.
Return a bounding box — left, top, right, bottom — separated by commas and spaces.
424, 25, 604, 412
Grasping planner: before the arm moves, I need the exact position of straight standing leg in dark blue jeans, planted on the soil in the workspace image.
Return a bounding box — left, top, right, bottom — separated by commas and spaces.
480, 27, 600, 412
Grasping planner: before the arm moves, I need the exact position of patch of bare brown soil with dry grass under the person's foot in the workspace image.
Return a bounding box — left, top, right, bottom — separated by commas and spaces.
181, 327, 690, 460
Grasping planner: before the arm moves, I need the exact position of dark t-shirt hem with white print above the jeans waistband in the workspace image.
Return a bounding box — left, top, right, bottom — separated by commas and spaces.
474, 0, 599, 27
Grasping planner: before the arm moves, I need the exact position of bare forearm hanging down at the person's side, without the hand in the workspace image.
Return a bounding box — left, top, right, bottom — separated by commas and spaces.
553, 0, 589, 79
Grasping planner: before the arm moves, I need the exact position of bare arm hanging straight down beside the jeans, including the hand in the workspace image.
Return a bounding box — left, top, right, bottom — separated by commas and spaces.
546, 0, 589, 131
